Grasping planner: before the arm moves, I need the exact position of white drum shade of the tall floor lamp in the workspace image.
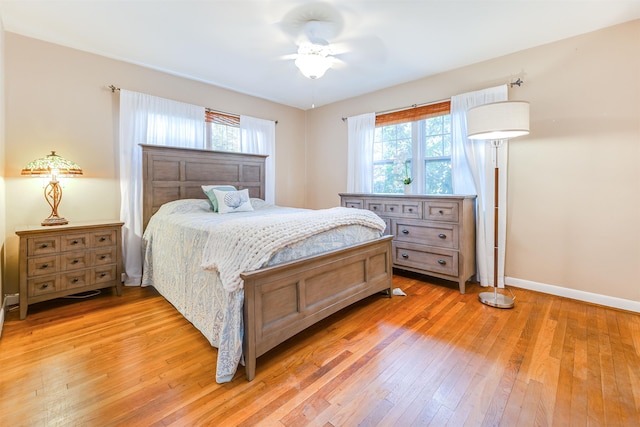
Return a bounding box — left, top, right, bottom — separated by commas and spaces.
467, 101, 529, 140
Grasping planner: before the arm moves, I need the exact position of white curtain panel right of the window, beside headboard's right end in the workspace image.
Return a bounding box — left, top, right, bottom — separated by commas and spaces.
240, 116, 276, 203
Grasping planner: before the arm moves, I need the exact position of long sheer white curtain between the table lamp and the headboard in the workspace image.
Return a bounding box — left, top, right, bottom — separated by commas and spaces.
119, 89, 204, 286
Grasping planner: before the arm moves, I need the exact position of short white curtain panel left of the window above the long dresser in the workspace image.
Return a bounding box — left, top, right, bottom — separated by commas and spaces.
347, 113, 376, 193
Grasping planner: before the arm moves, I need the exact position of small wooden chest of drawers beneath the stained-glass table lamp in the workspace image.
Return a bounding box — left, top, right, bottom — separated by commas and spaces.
16, 221, 123, 319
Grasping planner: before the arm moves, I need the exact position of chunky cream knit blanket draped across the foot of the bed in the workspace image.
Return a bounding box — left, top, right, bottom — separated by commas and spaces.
202, 207, 385, 292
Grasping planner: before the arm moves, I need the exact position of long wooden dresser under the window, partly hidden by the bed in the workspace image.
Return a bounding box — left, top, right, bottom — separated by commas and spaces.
340, 193, 476, 294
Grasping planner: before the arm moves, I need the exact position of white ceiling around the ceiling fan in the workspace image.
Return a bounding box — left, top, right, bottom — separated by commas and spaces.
0, 0, 640, 109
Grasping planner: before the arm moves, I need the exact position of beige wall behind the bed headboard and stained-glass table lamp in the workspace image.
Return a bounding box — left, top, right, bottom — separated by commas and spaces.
0, 33, 305, 292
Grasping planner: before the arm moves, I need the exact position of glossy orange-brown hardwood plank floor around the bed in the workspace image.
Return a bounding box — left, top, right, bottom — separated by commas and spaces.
0, 276, 640, 426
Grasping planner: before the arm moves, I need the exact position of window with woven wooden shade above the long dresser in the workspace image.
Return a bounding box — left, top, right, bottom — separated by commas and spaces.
373, 101, 453, 194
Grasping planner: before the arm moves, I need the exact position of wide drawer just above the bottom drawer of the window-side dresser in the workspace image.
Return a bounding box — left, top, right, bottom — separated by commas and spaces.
394, 220, 458, 249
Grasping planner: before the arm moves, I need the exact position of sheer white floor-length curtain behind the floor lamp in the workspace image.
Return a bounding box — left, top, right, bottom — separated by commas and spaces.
451, 85, 508, 287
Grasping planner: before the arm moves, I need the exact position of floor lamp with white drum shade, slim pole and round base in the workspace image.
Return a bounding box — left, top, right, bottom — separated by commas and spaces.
467, 101, 529, 308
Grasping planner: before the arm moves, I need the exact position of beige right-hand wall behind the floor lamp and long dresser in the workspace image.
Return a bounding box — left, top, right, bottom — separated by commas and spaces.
307, 20, 640, 307
